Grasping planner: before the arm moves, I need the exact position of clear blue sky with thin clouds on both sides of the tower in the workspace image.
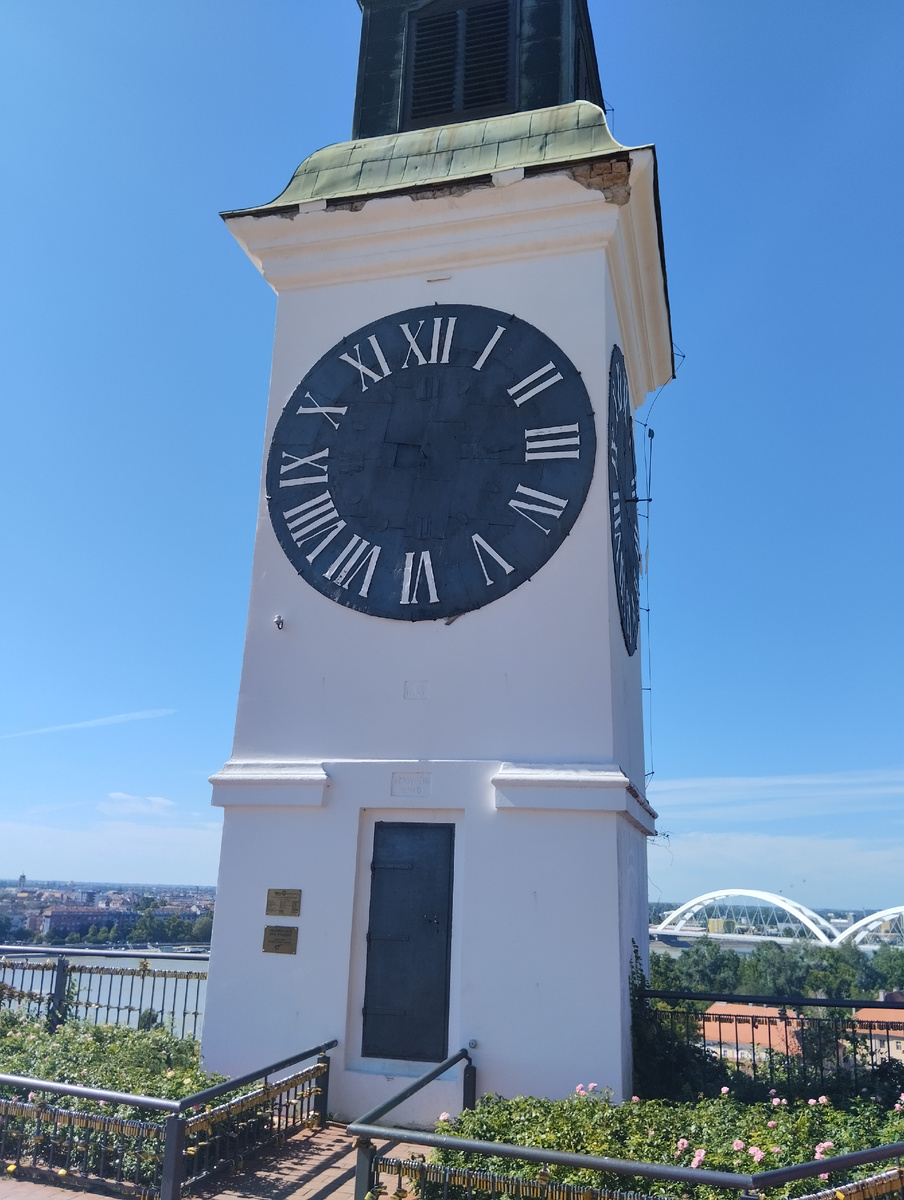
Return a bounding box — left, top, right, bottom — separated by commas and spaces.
0, 0, 904, 907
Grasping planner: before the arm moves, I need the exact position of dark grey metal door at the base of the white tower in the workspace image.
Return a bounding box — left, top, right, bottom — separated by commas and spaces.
361, 821, 455, 1062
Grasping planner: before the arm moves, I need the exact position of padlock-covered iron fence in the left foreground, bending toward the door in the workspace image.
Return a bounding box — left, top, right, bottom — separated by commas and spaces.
0, 1042, 337, 1200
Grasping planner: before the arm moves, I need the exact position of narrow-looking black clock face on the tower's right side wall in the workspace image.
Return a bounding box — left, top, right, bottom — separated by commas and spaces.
609, 346, 640, 654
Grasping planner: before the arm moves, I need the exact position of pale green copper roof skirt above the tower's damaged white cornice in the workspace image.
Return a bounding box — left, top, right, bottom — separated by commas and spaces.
223, 100, 625, 216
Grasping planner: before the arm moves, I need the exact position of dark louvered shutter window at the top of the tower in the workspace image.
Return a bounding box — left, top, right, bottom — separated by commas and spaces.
408, 0, 511, 125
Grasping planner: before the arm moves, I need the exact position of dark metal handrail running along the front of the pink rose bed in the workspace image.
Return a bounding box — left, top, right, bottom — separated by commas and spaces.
348, 1121, 904, 1192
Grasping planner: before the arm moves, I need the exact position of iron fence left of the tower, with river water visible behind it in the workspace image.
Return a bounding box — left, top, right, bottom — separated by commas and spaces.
0, 955, 208, 1038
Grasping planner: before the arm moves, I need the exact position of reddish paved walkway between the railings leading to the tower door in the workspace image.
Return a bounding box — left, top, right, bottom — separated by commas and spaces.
0, 1124, 424, 1200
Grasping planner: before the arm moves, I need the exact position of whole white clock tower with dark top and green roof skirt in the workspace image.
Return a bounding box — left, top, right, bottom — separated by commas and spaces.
203, 0, 672, 1123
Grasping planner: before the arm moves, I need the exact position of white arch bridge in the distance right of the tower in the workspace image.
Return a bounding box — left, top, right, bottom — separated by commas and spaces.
649, 888, 904, 946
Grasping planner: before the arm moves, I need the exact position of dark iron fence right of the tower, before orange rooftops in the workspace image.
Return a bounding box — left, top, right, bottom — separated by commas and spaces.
634, 990, 904, 1100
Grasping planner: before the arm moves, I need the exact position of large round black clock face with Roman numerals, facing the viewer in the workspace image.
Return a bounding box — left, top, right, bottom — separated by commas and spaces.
267, 305, 595, 620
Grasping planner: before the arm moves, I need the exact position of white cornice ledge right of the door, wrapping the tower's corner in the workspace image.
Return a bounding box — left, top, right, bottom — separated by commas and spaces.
491, 762, 657, 833
